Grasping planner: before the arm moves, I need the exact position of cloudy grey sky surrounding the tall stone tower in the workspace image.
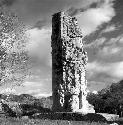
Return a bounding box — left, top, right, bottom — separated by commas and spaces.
0, 0, 123, 96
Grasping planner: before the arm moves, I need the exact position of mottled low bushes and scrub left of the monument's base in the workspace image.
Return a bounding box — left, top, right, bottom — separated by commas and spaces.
0, 94, 50, 117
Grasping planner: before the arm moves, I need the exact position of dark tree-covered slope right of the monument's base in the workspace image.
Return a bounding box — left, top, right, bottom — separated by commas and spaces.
87, 80, 123, 117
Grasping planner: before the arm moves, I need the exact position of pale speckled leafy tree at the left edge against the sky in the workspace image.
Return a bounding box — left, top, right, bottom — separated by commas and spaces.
0, 11, 29, 85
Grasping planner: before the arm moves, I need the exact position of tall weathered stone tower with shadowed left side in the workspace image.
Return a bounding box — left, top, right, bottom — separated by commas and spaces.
51, 12, 95, 113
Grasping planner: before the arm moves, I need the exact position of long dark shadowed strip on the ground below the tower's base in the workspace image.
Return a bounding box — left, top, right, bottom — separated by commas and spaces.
30, 112, 107, 122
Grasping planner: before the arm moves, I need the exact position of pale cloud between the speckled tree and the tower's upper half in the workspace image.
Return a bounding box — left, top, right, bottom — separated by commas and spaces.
27, 28, 51, 66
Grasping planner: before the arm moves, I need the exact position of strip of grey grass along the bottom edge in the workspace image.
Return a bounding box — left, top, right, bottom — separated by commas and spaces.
0, 117, 109, 125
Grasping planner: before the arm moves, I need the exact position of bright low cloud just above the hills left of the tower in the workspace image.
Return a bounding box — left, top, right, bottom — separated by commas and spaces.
15, 74, 52, 96
